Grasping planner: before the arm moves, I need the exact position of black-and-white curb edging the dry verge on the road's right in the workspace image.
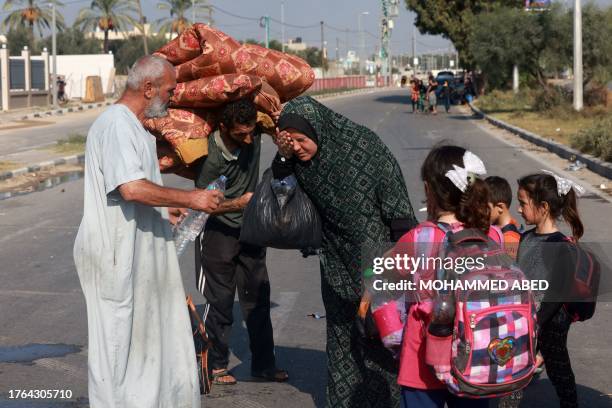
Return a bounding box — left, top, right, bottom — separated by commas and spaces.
469, 103, 612, 180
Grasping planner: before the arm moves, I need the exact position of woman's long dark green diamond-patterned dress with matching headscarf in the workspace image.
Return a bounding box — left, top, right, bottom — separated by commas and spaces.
283, 97, 416, 408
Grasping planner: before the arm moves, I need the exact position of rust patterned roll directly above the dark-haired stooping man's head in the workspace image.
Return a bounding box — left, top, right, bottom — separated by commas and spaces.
170, 74, 262, 108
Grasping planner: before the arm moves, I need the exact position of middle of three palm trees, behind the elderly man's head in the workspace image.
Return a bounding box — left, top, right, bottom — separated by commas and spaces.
74, 0, 139, 53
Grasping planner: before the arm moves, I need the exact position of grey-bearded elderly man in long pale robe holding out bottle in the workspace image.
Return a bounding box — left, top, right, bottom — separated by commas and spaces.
74, 56, 223, 408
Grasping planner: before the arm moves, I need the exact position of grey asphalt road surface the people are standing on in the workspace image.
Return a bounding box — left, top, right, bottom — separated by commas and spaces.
0, 92, 612, 408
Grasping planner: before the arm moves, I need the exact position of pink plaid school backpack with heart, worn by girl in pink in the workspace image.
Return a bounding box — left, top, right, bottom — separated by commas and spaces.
416, 223, 536, 398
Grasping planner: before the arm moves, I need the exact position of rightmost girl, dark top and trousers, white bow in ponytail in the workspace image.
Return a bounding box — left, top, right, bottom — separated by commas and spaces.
518, 170, 585, 407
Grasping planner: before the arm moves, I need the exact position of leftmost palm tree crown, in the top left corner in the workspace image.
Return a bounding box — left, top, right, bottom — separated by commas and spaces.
2, 0, 66, 42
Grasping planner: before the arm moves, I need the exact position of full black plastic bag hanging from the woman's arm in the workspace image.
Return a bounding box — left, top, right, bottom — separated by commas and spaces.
240, 169, 321, 250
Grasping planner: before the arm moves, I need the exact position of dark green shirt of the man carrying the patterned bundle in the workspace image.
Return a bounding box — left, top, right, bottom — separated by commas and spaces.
196, 130, 261, 228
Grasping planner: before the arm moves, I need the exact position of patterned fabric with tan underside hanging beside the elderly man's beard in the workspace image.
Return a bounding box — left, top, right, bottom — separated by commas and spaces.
144, 108, 217, 164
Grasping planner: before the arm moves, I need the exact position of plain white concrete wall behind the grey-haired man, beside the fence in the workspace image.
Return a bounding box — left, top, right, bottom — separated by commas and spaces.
56, 54, 115, 98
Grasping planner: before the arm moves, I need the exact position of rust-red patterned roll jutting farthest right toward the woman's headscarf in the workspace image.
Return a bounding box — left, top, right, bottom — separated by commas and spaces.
175, 43, 314, 102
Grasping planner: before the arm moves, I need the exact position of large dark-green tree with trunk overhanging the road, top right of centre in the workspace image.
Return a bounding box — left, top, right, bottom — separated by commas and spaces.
405, 0, 525, 68
